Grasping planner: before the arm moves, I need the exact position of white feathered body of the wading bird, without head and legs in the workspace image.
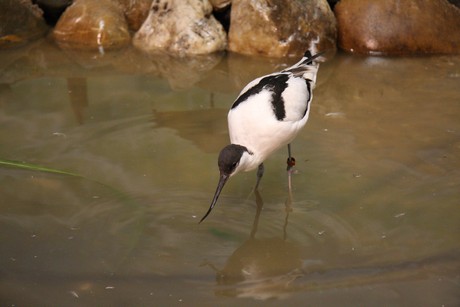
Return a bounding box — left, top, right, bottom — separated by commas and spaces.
228, 57, 318, 173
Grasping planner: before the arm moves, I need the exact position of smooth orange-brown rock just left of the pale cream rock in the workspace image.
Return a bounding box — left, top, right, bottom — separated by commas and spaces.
53, 0, 131, 51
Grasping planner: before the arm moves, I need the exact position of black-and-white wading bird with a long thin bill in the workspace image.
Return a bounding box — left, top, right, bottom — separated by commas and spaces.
199, 50, 323, 223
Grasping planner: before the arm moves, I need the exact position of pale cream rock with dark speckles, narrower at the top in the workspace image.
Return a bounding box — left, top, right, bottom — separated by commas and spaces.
133, 0, 227, 55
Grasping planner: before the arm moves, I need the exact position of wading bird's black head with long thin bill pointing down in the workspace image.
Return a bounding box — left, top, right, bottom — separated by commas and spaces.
200, 144, 249, 223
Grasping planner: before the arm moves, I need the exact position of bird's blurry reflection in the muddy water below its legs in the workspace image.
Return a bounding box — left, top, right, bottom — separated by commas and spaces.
205, 190, 303, 299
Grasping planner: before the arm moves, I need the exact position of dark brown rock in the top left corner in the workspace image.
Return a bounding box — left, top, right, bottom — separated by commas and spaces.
0, 0, 48, 49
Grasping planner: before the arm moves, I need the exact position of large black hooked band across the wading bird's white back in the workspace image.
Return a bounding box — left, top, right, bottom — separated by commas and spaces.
232, 73, 289, 120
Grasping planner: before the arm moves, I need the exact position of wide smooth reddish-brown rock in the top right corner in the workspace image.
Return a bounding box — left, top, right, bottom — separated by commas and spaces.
335, 0, 460, 54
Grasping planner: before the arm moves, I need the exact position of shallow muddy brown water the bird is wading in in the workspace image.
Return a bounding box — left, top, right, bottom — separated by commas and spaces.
0, 41, 460, 306
